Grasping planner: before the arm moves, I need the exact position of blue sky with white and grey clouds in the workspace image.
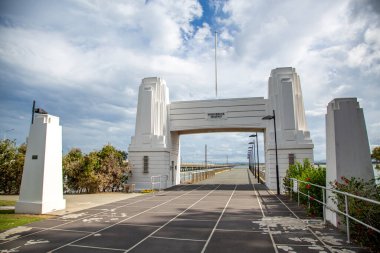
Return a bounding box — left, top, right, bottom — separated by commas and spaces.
0, 0, 380, 162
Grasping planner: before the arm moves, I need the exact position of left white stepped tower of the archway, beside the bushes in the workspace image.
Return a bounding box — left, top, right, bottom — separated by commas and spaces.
128, 77, 172, 190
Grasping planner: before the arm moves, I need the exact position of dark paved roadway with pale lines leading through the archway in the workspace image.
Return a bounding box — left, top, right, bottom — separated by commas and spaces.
0, 169, 366, 253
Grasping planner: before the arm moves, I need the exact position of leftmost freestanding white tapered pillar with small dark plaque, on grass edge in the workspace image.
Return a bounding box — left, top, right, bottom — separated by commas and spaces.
15, 114, 66, 214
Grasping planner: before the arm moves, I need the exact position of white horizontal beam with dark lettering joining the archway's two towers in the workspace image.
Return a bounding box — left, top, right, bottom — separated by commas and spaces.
169, 97, 268, 134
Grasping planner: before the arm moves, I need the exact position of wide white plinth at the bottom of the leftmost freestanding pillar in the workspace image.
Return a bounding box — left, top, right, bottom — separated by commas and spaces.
15, 199, 66, 214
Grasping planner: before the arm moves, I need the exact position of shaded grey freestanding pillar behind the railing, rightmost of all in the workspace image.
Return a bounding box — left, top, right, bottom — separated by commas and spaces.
326, 98, 374, 226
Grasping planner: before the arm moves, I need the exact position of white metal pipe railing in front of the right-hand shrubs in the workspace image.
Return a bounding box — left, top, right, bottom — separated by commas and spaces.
284, 178, 380, 243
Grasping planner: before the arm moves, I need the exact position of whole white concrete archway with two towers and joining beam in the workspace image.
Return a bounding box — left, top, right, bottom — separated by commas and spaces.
128, 67, 314, 189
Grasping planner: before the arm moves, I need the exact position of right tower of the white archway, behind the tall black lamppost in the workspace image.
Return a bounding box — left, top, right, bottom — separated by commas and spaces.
265, 67, 314, 192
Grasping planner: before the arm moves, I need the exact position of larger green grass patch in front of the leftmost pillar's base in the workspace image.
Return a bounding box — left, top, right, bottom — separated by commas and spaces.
0, 210, 53, 231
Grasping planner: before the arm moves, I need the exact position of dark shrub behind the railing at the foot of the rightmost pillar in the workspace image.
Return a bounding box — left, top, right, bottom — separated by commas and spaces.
331, 177, 380, 249
